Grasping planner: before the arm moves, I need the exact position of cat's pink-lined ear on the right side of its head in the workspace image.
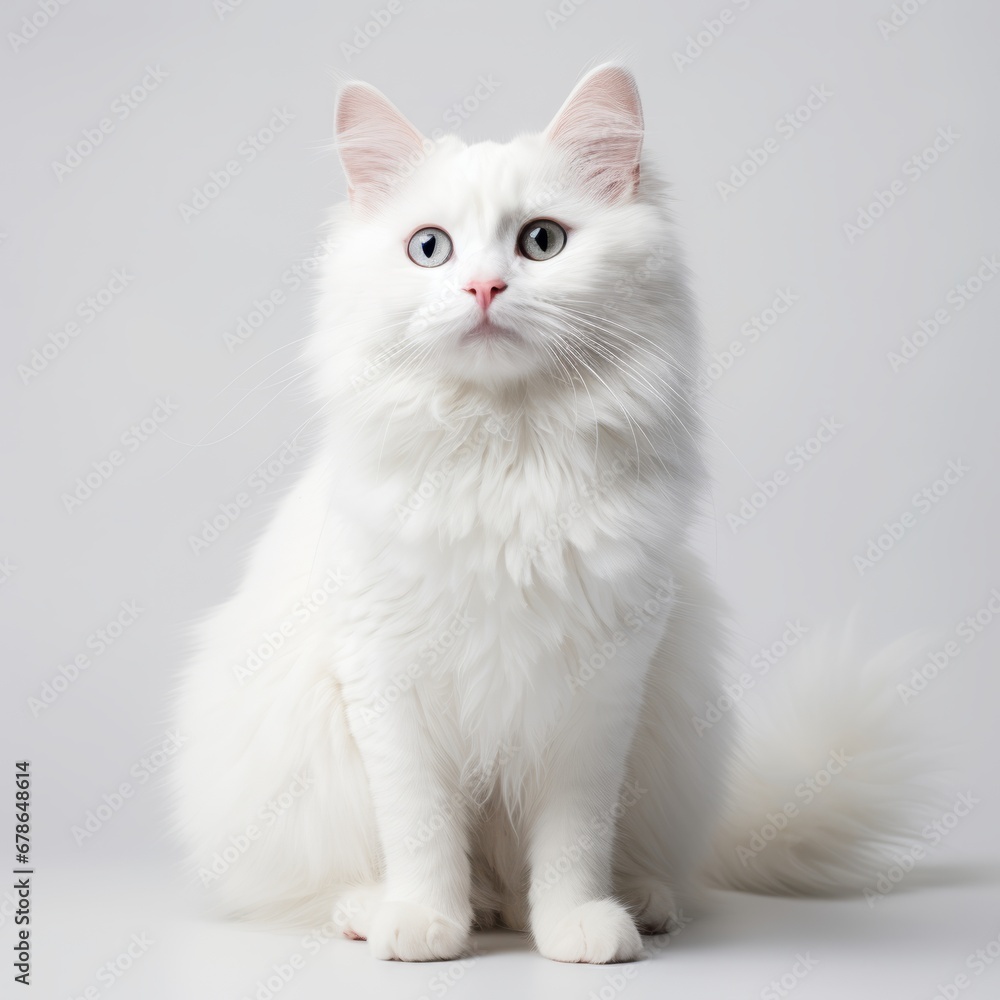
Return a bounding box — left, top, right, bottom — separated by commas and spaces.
545, 64, 642, 202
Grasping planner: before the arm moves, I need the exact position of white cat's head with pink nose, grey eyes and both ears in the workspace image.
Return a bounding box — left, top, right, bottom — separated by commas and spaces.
320, 65, 682, 394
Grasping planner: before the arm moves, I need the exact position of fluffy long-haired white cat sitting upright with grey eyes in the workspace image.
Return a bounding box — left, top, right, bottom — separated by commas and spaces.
174, 65, 928, 962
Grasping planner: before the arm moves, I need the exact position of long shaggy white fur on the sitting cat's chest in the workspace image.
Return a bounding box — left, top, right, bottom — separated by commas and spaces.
334, 410, 653, 773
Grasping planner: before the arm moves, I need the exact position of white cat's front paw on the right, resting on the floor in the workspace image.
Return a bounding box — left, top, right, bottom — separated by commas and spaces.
535, 899, 642, 965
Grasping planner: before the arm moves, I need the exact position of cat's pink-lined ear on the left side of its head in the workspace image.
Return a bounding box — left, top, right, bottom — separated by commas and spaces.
334, 81, 426, 208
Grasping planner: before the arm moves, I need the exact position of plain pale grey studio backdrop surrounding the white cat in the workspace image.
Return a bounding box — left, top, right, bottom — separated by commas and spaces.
0, 0, 1000, 1000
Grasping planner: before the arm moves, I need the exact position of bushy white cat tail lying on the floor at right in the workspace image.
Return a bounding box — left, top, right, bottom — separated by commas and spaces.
707, 625, 946, 896
